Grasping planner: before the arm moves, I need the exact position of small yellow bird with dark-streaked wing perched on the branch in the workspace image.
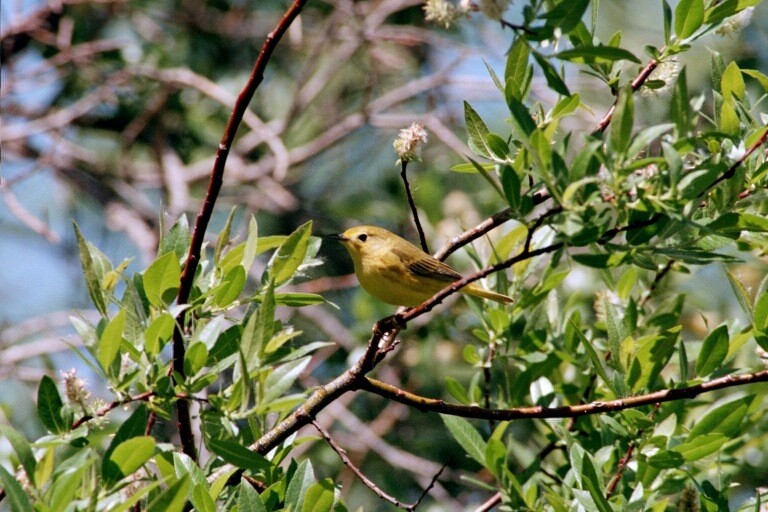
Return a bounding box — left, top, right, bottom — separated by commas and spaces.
331, 226, 514, 306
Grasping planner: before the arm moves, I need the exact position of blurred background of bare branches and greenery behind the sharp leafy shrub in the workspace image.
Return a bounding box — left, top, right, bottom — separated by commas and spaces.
0, 0, 768, 510
